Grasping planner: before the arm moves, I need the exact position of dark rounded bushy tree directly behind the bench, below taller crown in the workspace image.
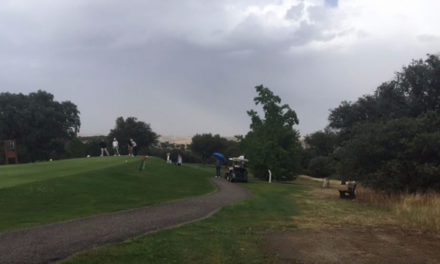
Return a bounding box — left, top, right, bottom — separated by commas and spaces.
341, 111, 440, 193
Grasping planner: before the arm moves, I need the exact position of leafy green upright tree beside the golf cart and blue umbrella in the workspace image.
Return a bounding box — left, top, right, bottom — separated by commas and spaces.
242, 85, 300, 180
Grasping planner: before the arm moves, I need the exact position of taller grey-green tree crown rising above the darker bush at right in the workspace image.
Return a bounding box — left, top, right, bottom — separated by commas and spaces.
329, 55, 440, 132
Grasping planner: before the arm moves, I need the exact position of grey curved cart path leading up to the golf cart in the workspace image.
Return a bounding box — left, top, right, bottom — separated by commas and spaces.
0, 179, 251, 263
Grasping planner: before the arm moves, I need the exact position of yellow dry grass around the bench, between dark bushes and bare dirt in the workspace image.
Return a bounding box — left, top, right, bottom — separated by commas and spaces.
299, 176, 440, 234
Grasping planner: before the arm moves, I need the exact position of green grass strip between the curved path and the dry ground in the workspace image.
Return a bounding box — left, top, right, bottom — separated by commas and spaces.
63, 179, 305, 263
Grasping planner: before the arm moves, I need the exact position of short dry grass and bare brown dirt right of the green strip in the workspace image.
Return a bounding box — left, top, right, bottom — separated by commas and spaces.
264, 177, 440, 264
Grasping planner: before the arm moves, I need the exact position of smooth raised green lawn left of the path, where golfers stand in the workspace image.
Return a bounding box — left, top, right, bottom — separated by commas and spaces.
0, 156, 214, 231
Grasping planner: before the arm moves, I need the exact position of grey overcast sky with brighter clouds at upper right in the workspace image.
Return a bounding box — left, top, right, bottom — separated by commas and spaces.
0, 0, 440, 136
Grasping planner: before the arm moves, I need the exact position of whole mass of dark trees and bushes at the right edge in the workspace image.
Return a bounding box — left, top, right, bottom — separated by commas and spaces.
309, 55, 440, 192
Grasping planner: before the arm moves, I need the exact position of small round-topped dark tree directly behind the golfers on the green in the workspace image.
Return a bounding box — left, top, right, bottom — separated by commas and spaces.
107, 116, 159, 154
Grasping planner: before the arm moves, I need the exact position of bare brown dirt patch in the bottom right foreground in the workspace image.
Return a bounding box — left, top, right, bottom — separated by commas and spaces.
265, 226, 440, 264
